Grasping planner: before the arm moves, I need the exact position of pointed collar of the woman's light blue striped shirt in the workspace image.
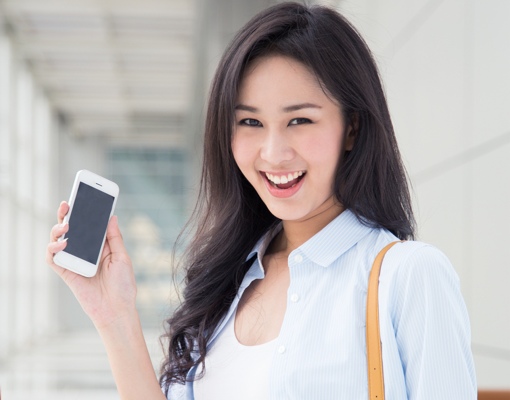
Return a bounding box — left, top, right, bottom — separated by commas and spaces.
247, 210, 373, 268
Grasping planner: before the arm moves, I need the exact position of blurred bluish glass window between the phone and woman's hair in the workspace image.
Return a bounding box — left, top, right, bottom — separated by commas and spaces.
108, 147, 188, 328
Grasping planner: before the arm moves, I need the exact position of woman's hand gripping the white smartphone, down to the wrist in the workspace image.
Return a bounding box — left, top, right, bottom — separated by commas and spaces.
46, 202, 136, 329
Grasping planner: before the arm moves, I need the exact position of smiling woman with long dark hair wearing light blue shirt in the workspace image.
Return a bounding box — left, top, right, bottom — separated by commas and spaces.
48, 3, 476, 400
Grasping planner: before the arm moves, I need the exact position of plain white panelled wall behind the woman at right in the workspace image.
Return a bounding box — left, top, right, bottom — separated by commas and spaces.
329, 0, 510, 388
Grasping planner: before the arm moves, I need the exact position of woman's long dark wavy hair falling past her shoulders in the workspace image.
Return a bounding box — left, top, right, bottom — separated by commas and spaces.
161, 3, 414, 389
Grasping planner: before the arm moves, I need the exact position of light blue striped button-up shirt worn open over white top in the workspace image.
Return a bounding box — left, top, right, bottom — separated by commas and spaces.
165, 210, 476, 400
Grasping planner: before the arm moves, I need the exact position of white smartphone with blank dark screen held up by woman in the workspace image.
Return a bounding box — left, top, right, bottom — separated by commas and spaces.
53, 170, 119, 277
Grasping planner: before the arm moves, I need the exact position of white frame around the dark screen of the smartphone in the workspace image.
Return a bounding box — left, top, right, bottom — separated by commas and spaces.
53, 169, 119, 278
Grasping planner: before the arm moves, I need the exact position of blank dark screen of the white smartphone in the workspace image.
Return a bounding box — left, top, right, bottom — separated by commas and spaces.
64, 182, 115, 264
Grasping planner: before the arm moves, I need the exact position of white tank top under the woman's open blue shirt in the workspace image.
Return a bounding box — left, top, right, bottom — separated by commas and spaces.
193, 312, 276, 400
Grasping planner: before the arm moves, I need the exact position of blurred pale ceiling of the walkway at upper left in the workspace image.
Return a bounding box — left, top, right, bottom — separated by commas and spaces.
0, 0, 198, 138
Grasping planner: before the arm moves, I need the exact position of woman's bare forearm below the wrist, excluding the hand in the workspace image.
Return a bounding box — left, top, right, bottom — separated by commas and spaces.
96, 311, 165, 400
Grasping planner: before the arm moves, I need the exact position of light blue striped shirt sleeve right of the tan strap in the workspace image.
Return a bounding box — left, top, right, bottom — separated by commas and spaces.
392, 245, 476, 400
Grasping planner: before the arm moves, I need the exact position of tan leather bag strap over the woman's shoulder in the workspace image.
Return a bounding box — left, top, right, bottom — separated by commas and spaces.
366, 241, 400, 400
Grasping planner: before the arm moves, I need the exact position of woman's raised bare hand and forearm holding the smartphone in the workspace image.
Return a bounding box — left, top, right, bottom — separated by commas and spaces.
46, 202, 165, 400
